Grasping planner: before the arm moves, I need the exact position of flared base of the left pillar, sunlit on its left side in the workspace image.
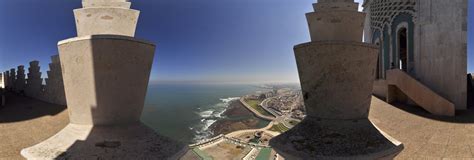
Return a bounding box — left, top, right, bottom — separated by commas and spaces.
21, 123, 187, 160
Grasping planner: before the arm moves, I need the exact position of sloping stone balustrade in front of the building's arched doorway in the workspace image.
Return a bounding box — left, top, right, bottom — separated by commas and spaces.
387, 69, 455, 116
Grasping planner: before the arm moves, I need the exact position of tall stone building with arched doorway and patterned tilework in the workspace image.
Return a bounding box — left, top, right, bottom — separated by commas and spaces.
363, 0, 468, 110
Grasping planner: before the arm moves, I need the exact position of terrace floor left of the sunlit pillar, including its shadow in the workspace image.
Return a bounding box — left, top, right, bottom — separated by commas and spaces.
0, 94, 69, 160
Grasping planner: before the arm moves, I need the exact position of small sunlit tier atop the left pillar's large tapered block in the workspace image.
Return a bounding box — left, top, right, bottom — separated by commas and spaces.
74, 7, 140, 37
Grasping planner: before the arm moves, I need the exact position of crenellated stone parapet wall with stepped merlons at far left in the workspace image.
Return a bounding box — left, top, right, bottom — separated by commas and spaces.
3, 55, 66, 105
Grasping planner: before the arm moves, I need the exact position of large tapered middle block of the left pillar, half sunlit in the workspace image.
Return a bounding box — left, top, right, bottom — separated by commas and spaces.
59, 35, 155, 125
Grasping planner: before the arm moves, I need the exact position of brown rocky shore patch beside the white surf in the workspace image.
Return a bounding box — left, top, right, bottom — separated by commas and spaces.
209, 100, 268, 136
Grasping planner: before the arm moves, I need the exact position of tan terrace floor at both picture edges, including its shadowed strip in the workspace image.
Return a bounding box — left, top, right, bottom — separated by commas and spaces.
0, 94, 474, 160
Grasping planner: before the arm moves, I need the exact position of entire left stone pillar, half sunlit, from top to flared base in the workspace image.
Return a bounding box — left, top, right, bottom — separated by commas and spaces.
21, 0, 186, 159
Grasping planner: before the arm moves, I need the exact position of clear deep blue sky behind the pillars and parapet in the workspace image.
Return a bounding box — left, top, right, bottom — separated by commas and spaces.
0, 0, 474, 83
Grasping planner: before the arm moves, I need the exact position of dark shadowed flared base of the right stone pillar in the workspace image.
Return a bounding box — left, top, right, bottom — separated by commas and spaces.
270, 117, 403, 160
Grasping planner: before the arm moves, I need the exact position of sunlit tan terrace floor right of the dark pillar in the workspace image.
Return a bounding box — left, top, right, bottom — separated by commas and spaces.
369, 97, 474, 160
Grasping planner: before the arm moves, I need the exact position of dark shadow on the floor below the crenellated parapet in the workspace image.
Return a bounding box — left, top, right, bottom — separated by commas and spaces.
0, 92, 66, 123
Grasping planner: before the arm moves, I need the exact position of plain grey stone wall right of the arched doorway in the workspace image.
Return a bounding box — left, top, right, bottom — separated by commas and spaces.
414, 0, 467, 110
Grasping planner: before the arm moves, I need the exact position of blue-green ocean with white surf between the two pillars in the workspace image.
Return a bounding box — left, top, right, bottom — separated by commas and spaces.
141, 84, 266, 143
